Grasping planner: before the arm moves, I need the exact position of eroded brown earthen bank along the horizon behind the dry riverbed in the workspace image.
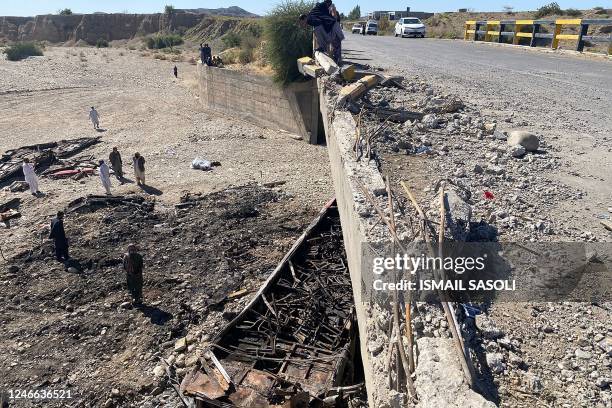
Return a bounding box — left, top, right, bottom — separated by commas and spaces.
0, 8, 258, 44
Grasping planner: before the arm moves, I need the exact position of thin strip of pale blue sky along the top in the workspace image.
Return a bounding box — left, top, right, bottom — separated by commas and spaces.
0, 0, 612, 16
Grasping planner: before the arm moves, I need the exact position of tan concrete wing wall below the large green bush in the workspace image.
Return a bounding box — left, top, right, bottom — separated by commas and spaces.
198, 63, 319, 144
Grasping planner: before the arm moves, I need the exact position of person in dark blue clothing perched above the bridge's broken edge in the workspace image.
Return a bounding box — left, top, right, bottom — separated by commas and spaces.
300, 0, 344, 62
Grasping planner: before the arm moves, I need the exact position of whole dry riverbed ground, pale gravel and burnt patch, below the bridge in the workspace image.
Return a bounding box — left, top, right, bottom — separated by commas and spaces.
0, 47, 333, 406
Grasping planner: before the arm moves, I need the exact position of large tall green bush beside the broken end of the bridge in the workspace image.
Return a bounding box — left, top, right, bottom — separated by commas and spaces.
264, 0, 314, 84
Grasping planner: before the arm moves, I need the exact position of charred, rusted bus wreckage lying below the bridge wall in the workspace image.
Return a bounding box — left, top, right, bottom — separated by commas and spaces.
181, 200, 364, 408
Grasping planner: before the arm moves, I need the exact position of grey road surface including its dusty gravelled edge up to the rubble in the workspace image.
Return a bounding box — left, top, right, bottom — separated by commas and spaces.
343, 34, 612, 236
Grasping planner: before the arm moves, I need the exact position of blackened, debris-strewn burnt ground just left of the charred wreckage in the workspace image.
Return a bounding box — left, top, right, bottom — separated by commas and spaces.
0, 185, 320, 408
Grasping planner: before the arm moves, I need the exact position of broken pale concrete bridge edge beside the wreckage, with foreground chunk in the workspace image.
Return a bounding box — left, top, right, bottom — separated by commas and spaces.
319, 80, 495, 408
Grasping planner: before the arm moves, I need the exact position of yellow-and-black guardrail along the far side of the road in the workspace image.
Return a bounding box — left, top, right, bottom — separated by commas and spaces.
464, 18, 612, 54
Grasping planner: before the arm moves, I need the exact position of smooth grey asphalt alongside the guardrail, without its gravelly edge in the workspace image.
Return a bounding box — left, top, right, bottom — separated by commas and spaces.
344, 34, 612, 134
